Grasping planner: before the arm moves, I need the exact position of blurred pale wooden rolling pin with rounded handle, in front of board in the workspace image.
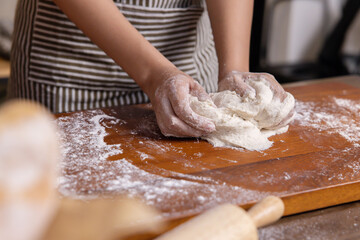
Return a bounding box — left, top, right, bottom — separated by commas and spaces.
156, 196, 284, 240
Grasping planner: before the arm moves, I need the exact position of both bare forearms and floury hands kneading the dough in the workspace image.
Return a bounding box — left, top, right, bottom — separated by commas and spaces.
54, 0, 294, 137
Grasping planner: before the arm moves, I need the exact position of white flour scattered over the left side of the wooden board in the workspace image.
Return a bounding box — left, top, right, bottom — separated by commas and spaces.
56, 110, 267, 217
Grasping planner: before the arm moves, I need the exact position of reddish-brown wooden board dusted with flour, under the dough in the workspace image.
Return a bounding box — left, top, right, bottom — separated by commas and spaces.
57, 79, 360, 219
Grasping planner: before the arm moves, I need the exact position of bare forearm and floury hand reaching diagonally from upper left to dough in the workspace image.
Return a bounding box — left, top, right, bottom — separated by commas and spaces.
54, 0, 215, 137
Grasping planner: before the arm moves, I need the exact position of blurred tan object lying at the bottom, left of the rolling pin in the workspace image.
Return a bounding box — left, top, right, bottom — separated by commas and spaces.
44, 198, 164, 240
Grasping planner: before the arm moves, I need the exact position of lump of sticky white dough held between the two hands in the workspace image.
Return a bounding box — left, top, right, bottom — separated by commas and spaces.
190, 79, 295, 150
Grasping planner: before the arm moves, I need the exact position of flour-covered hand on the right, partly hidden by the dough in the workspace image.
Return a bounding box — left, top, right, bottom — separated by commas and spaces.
218, 71, 295, 128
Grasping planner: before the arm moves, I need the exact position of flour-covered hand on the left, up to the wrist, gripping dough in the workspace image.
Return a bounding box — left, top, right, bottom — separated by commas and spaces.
148, 73, 215, 137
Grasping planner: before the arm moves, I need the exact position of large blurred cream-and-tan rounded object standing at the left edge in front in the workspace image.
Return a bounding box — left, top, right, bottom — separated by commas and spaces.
0, 101, 60, 240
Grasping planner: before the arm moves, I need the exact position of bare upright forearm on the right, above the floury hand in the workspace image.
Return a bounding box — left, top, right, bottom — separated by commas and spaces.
206, 0, 253, 79
